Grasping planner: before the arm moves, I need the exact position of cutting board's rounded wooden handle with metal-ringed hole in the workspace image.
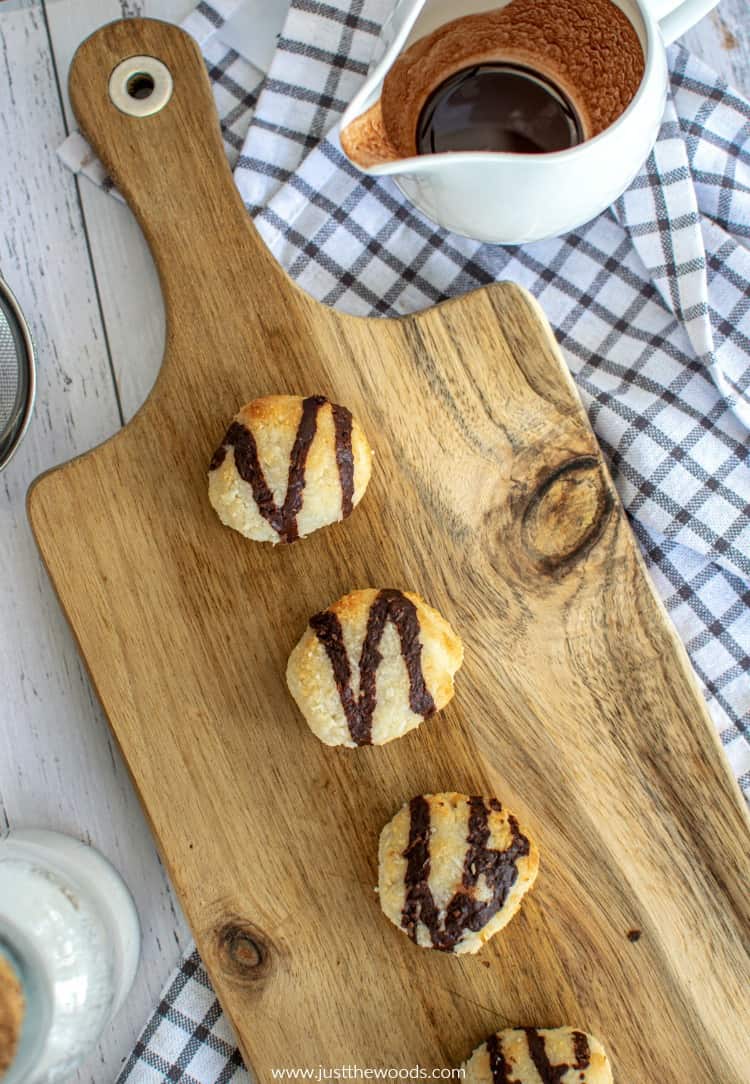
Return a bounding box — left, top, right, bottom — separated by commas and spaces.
69, 18, 286, 314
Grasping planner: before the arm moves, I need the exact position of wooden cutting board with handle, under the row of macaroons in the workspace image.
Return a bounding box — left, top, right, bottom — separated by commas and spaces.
29, 20, 750, 1084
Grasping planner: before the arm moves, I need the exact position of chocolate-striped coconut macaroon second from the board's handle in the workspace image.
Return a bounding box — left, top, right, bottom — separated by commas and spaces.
286, 588, 464, 748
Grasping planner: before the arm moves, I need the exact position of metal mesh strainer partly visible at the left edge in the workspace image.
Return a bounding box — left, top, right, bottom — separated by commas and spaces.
0, 279, 35, 470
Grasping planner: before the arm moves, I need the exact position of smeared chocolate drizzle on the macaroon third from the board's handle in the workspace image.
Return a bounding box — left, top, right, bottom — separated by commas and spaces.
401, 796, 529, 953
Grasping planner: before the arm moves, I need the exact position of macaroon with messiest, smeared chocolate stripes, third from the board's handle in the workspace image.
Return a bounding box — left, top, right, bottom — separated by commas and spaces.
378, 793, 539, 955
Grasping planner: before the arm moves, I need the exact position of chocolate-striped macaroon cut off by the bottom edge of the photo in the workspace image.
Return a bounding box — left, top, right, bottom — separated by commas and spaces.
464, 1028, 612, 1084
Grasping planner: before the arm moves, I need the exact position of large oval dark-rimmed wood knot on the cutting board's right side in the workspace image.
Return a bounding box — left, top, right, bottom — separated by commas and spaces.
521, 455, 615, 573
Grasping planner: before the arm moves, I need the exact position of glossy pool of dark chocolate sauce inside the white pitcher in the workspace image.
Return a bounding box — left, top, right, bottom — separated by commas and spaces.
416, 63, 583, 154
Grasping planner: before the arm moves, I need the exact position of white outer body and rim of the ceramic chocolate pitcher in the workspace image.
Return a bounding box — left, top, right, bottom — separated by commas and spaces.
341, 0, 717, 245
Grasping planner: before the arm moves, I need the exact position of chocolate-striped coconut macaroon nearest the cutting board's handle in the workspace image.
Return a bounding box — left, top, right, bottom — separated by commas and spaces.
208, 396, 373, 544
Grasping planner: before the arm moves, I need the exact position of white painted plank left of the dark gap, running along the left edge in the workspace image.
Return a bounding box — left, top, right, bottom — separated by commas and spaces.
0, 2, 185, 1084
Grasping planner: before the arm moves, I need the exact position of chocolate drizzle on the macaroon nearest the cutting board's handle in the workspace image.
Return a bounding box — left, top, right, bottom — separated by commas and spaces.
208, 396, 354, 542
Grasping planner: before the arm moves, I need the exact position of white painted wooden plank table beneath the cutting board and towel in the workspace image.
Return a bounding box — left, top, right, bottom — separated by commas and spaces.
0, 0, 750, 1084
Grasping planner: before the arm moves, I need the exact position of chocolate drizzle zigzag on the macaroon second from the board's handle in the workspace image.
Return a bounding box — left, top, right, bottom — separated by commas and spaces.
310, 589, 435, 746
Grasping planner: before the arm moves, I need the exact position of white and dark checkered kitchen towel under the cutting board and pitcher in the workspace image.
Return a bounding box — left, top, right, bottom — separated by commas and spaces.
61, 0, 750, 1084
